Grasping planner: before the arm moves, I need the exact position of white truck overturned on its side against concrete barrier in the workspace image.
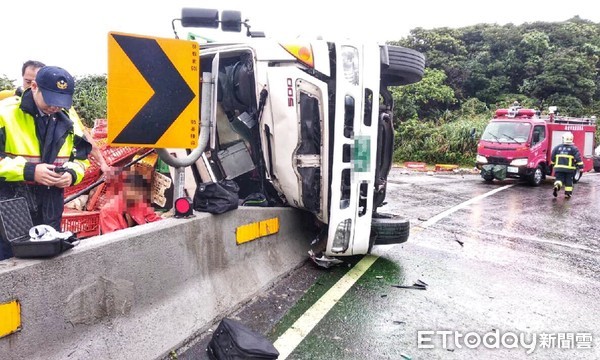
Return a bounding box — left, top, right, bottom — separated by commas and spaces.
161, 8, 425, 261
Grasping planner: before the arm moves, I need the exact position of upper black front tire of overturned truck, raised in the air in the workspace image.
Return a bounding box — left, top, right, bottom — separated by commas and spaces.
380, 45, 425, 86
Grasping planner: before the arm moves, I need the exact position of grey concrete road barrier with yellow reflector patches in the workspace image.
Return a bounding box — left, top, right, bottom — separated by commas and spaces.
0, 208, 311, 360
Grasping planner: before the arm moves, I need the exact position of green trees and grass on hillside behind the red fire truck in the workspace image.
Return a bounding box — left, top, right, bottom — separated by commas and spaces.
391, 17, 600, 166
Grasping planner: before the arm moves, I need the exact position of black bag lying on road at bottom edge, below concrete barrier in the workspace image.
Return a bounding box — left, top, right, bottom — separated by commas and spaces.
206, 318, 279, 360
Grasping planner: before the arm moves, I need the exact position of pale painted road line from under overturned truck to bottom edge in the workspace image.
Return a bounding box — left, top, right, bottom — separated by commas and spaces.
274, 255, 379, 360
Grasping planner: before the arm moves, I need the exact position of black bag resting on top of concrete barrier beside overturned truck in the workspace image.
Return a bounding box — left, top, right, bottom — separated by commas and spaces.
194, 179, 240, 214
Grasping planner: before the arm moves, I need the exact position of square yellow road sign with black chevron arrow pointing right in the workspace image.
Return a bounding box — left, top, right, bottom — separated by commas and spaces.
108, 33, 200, 149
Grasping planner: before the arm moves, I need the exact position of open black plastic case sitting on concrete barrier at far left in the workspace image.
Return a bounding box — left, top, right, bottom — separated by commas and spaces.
0, 198, 73, 258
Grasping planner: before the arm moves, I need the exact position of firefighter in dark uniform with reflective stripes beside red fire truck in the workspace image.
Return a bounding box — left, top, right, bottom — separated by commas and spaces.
550, 132, 583, 198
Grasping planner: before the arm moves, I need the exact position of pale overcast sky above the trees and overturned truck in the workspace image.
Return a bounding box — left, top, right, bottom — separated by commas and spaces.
0, 0, 600, 84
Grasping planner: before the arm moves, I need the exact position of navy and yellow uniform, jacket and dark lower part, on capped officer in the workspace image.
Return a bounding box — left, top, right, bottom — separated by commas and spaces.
0, 90, 92, 231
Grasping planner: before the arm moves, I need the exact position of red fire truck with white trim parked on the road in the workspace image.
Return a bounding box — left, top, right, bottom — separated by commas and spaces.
476, 105, 596, 186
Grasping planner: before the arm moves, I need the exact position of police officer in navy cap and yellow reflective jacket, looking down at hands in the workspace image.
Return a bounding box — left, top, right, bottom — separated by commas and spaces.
0, 66, 92, 260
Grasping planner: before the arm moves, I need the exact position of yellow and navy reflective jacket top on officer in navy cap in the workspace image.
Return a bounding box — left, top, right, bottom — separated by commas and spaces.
0, 91, 91, 185
